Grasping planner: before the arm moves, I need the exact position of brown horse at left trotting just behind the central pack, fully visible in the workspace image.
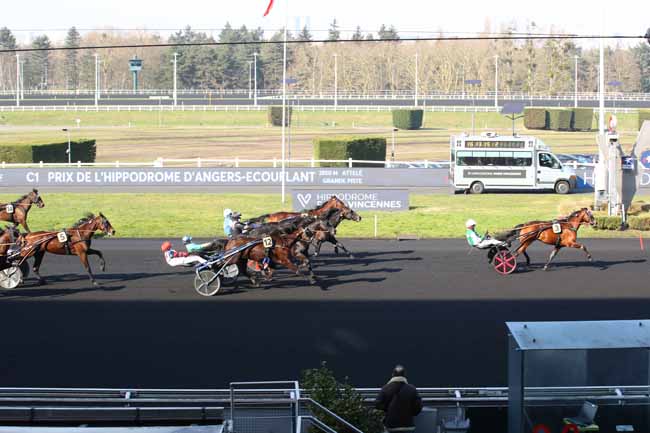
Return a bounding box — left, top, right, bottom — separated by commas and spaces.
20, 213, 115, 286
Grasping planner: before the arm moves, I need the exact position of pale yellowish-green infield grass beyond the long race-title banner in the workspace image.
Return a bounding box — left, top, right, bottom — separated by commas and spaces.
0, 107, 637, 162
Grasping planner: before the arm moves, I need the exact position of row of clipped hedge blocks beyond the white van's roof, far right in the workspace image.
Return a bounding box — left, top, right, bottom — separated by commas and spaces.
524, 108, 594, 131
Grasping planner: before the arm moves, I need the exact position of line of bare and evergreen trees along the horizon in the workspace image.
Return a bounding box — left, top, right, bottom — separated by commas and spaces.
0, 20, 650, 95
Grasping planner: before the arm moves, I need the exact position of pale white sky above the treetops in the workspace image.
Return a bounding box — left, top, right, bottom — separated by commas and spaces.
0, 0, 650, 43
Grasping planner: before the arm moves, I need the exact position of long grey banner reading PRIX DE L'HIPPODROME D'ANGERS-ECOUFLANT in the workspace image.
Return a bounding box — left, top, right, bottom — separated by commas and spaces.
0, 167, 448, 188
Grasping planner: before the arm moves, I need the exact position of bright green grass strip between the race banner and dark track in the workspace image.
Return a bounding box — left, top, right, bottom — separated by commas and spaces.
0, 193, 650, 238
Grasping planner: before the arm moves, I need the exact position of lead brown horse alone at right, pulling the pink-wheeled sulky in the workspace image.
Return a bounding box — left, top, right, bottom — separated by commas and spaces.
510, 208, 596, 270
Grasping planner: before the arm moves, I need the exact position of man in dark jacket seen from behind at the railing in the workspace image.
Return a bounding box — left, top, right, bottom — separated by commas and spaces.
375, 365, 422, 432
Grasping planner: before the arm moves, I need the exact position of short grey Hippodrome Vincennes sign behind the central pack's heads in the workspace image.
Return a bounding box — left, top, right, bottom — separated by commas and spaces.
291, 189, 409, 212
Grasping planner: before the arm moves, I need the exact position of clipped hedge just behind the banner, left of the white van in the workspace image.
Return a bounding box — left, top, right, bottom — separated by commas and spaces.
314, 137, 386, 167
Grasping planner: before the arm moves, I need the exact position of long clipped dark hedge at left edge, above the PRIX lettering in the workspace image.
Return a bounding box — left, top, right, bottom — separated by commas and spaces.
0, 139, 97, 163
